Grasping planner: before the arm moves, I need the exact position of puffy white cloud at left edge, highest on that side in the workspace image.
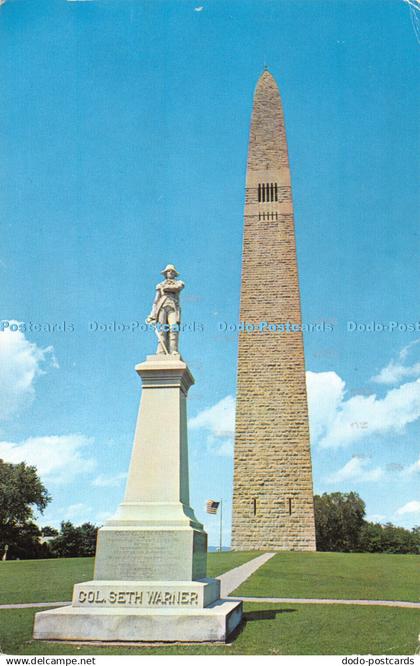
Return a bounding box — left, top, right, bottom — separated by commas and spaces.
0, 321, 58, 420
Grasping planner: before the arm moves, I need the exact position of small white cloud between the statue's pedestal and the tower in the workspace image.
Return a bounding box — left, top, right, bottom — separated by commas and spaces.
188, 395, 235, 456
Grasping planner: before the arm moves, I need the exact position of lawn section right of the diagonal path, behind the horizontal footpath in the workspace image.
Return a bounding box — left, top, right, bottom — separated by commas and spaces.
233, 552, 420, 600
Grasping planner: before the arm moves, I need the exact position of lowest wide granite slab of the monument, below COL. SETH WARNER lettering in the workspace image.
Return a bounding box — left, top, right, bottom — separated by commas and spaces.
34, 599, 242, 642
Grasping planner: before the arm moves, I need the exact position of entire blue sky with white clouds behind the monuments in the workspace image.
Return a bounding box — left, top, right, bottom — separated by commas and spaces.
0, 0, 420, 545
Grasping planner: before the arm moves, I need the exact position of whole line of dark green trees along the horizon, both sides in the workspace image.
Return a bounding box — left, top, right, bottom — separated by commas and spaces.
0, 460, 420, 559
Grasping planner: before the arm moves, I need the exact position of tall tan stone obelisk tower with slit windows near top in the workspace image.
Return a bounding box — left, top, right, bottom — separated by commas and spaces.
232, 71, 316, 550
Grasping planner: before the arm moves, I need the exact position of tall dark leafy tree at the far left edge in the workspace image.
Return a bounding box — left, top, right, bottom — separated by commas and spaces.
0, 460, 51, 559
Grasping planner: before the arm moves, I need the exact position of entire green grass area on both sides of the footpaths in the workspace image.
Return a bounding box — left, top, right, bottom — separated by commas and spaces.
0, 552, 420, 657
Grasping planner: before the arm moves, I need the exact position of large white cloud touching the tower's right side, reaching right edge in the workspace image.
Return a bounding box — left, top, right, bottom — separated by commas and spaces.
307, 372, 420, 448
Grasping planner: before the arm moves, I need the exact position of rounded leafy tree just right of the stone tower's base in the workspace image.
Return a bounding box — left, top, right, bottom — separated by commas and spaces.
314, 492, 365, 552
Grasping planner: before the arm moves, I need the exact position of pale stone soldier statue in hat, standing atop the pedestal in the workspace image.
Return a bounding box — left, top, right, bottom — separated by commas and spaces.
146, 264, 185, 354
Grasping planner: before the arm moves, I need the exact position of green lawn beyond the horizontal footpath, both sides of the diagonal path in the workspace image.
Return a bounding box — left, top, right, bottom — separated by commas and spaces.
0, 552, 420, 604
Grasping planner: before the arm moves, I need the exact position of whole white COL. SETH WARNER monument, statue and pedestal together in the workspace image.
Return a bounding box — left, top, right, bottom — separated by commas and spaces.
34, 264, 242, 642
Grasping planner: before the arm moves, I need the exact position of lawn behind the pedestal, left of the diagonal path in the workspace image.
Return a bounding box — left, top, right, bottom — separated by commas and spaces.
0, 552, 259, 604
